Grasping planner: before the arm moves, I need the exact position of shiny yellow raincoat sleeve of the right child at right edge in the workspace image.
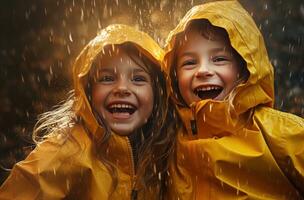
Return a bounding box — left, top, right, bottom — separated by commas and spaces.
255, 107, 304, 194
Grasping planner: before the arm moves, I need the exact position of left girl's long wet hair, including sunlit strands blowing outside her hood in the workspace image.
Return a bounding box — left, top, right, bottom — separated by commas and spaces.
32, 43, 176, 199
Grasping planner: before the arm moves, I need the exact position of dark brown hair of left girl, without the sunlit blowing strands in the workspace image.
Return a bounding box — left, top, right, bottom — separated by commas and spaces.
87, 43, 175, 197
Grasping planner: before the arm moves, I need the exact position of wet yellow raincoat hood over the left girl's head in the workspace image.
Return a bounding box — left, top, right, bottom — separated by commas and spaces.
73, 24, 163, 139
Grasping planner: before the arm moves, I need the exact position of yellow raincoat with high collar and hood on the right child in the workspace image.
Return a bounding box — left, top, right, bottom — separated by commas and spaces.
164, 1, 304, 200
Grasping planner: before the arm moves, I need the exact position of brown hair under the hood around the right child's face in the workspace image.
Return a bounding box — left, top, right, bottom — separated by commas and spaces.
170, 19, 249, 108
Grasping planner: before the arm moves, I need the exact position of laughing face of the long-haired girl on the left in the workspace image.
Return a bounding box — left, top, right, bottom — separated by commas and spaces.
92, 49, 154, 136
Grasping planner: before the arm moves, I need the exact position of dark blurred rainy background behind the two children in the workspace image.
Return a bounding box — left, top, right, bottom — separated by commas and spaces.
0, 0, 304, 184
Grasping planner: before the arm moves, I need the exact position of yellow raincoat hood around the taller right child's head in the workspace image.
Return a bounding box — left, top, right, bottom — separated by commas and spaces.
164, 1, 274, 122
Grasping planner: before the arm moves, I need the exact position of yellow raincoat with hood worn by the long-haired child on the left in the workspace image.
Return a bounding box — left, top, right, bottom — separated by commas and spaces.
0, 25, 163, 200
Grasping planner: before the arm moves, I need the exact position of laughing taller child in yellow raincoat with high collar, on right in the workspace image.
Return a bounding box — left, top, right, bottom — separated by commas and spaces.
164, 1, 304, 200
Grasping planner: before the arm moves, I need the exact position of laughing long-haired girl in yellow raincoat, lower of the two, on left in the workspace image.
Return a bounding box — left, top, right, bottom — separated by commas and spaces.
0, 25, 174, 200
